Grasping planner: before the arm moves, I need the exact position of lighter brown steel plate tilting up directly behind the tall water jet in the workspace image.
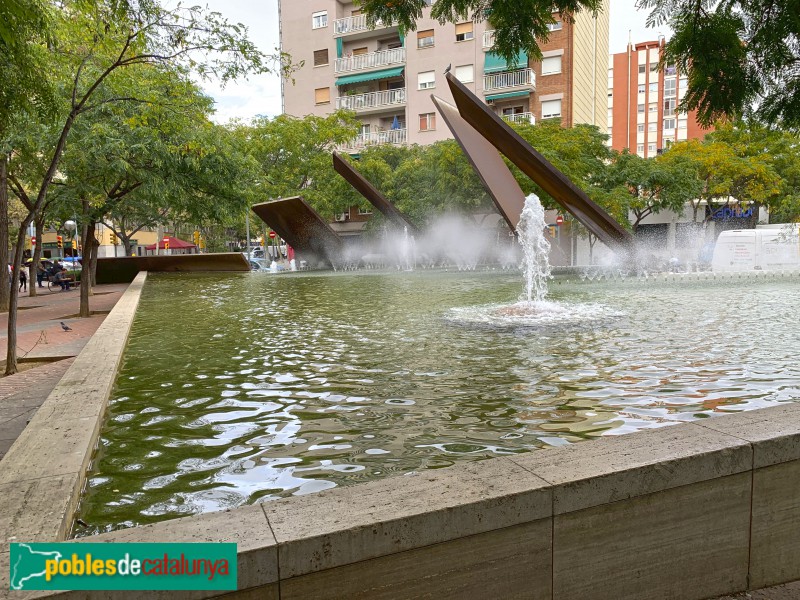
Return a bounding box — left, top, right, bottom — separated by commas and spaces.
431, 96, 525, 231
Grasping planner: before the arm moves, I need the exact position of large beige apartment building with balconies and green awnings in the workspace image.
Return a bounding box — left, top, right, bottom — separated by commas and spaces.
279, 0, 609, 152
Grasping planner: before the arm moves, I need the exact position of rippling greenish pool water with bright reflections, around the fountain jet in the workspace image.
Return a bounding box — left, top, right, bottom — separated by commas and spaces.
79, 272, 800, 532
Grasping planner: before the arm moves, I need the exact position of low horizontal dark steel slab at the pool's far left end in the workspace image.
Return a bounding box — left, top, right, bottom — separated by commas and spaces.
97, 252, 250, 283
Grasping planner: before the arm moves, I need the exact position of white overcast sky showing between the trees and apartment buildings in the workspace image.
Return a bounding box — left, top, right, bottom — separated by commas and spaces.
204, 0, 669, 123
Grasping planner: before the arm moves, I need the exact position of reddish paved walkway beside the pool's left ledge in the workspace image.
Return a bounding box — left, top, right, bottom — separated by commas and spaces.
0, 284, 128, 459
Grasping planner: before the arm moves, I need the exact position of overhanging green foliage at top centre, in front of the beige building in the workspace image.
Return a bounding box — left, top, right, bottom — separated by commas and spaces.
361, 0, 602, 63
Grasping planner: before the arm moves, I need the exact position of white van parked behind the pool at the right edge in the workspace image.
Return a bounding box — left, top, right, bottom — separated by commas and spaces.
711, 223, 800, 272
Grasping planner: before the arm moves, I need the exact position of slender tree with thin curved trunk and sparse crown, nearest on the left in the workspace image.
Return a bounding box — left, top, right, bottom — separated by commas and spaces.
6, 2, 289, 374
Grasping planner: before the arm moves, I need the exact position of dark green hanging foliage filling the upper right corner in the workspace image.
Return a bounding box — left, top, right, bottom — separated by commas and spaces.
638, 0, 800, 129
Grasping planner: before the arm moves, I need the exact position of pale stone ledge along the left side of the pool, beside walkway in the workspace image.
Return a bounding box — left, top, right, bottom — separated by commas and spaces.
0, 273, 147, 552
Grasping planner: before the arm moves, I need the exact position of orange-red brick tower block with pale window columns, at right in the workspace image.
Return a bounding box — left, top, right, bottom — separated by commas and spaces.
608, 38, 709, 158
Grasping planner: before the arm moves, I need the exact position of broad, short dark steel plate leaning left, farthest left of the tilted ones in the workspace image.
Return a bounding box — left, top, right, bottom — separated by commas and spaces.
253, 196, 342, 267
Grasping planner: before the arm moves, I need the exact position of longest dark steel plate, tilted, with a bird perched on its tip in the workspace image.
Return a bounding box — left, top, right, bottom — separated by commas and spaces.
445, 73, 633, 251
